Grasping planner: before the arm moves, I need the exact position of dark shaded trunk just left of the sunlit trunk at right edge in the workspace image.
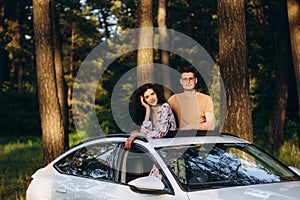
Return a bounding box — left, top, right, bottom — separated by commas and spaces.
268, 1, 291, 147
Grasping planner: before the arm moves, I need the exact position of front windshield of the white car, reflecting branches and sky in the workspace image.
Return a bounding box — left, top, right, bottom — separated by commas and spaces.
156, 144, 299, 191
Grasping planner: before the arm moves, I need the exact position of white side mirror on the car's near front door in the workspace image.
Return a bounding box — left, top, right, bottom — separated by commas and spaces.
128, 176, 165, 194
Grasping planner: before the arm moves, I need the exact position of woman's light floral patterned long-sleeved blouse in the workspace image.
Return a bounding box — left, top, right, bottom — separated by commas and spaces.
141, 103, 176, 139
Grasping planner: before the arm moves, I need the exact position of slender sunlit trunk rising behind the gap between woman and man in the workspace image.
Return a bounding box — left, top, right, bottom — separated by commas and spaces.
157, 0, 171, 99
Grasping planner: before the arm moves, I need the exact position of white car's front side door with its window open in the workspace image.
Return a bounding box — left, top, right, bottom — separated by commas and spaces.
105, 144, 187, 200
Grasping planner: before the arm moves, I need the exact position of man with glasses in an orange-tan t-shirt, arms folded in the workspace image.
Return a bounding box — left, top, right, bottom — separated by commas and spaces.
168, 67, 215, 130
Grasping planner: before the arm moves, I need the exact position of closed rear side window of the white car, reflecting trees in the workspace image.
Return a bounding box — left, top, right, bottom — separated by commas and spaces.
54, 143, 121, 180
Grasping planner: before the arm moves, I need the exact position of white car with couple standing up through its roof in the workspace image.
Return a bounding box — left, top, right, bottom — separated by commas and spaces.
26, 131, 300, 200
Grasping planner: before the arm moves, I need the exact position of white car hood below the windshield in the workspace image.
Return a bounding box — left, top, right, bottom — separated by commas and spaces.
188, 181, 300, 200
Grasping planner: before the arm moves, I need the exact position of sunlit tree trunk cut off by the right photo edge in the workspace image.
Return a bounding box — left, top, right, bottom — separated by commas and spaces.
286, 0, 300, 116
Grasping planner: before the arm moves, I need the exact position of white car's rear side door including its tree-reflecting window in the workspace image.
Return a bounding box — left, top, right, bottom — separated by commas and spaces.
53, 142, 120, 200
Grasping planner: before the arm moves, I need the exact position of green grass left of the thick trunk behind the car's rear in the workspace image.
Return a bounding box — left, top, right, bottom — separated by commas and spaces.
0, 137, 43, 200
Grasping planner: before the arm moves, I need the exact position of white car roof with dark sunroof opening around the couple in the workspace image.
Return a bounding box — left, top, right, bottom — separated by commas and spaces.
83, 130, 249, 148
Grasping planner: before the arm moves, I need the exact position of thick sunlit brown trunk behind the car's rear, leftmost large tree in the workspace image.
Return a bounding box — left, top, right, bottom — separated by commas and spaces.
33, 0, 65, 164
